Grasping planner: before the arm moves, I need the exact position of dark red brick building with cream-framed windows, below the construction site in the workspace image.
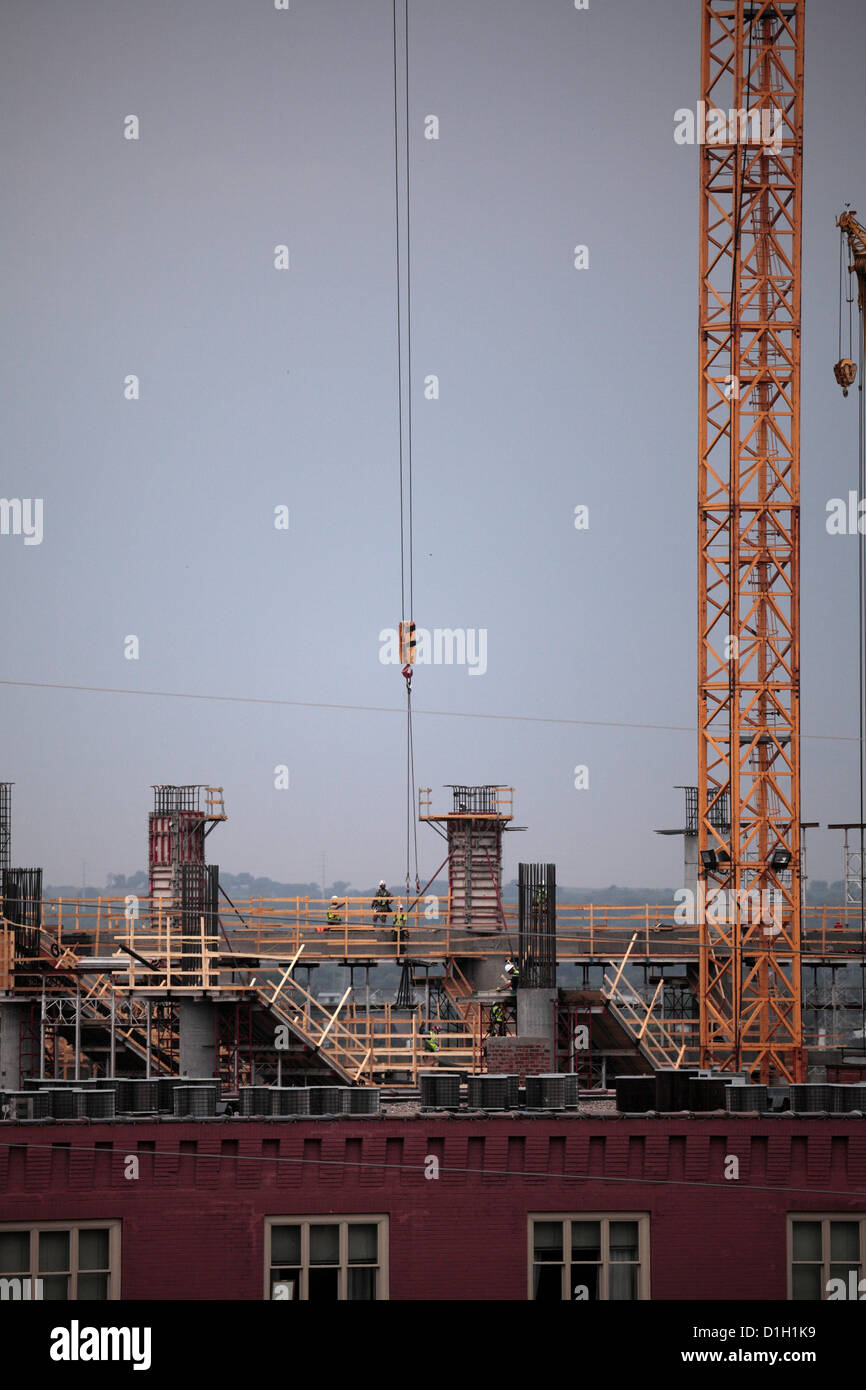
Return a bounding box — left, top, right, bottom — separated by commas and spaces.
0, 1113, 866, 1301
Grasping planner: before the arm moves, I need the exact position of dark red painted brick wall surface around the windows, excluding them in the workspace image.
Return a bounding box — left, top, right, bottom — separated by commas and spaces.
0, 1113, 866, 1301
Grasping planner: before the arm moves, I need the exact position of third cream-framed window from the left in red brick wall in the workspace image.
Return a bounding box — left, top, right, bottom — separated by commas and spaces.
530, 1212, 649, 1302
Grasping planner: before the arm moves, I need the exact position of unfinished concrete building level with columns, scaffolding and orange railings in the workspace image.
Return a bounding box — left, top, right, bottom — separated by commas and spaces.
0, 784, 866, 1109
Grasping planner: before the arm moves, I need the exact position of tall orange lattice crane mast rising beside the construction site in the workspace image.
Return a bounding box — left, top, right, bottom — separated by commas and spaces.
698, 0, 805, 1081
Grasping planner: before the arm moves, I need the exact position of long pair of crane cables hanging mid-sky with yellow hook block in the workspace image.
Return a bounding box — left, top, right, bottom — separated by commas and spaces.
392, 0, 421, 898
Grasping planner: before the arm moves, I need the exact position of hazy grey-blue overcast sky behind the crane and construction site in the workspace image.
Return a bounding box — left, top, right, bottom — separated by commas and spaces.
0, 0, 866, 887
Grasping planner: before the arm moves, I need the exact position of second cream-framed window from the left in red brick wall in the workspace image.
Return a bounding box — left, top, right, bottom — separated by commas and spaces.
264, 1216, 388, 1302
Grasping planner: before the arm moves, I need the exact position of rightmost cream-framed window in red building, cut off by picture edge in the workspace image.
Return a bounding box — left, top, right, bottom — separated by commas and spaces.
788, 1212, 866, 1302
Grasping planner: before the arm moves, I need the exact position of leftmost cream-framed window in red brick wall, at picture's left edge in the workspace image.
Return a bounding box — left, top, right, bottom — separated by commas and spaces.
0, 1222, 121, 1302
